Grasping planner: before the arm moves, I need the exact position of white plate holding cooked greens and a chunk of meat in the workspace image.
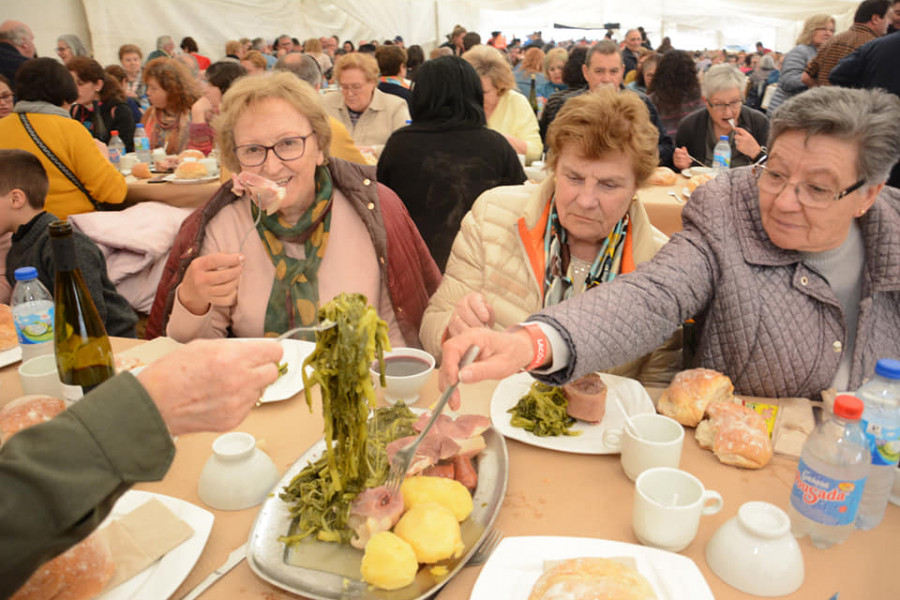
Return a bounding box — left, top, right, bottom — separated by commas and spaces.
491, 373, 656, 454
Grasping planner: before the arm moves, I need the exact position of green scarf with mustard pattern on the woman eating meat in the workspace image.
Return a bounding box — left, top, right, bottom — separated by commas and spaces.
260, 166, 334, 339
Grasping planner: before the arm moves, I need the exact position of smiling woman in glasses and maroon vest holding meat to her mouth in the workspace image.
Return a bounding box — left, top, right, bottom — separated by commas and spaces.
147, 73, 440, 346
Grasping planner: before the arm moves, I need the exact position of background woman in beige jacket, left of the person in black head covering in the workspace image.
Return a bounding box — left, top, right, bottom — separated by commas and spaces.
323, 52, 409, 154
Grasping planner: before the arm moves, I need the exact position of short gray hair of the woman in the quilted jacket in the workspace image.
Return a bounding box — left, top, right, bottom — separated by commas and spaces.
769, 86, 900, 185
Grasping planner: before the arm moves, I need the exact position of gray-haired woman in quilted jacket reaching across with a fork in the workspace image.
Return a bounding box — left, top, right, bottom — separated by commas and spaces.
441, 87, 900, 406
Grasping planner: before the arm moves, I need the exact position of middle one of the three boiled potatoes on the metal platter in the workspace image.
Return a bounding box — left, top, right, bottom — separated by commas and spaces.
394, 502, 465, 563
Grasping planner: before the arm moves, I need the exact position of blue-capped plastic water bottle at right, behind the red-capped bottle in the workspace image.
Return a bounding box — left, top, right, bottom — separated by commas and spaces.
856, 358, 900, 529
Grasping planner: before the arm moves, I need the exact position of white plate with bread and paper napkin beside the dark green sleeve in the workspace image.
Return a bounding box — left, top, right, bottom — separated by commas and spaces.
97, 490, 215, 600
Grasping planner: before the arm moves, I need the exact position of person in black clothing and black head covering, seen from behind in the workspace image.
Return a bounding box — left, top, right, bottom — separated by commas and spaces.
378, 56, 525, 270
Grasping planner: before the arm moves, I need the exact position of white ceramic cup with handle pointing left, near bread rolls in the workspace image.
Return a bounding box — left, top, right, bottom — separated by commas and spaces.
603, 413, 684, 481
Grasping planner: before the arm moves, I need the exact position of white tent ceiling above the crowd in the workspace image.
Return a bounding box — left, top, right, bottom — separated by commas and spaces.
0, 0, 858, 64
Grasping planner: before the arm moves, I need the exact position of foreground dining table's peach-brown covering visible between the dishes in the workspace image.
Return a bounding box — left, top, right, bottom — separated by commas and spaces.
0, 338, 900, 600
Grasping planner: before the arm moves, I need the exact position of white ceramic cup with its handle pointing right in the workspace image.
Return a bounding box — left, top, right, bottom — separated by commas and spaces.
631, 467, 723, 552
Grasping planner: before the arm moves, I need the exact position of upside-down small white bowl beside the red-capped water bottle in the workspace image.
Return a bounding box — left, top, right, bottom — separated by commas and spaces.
706, 502, 804, 597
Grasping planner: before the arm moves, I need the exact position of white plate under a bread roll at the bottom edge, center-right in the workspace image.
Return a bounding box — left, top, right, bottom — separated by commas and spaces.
469, 536, 713, 600
